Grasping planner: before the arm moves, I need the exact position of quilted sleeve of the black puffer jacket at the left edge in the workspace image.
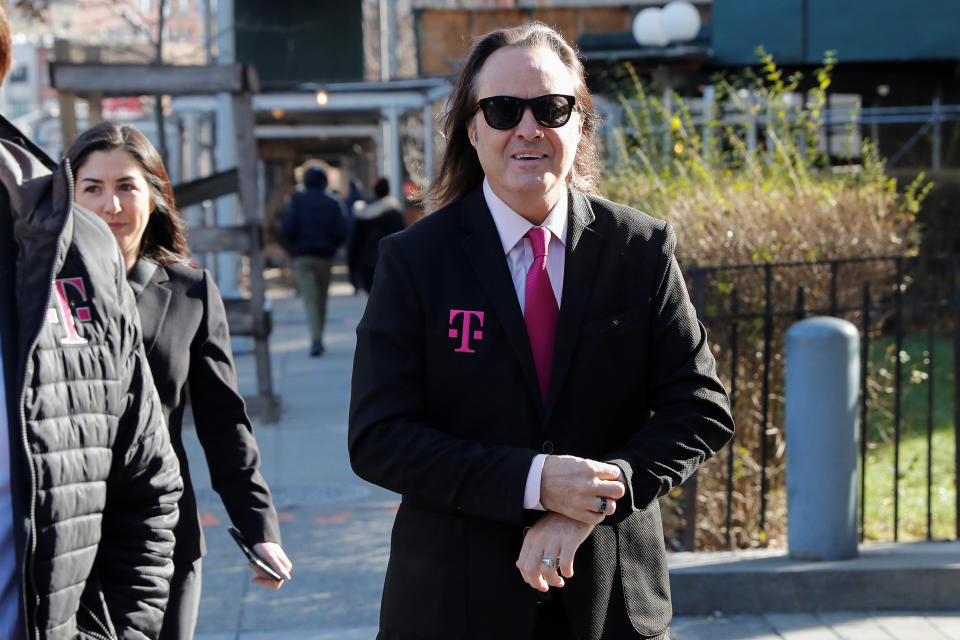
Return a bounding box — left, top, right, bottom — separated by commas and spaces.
97, 252, 183, 640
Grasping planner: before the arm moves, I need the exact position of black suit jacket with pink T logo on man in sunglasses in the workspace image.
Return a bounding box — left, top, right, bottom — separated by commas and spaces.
349, 188, 733, 640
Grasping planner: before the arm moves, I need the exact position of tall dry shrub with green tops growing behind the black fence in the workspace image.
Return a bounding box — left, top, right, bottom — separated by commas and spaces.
601, 52, 929, 549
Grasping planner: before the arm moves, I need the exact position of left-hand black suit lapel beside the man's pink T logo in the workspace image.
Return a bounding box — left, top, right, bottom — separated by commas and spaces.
461, 188, 548, 405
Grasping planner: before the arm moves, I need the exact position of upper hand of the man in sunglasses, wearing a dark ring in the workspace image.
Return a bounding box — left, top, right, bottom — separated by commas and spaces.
540, 456, 626, 525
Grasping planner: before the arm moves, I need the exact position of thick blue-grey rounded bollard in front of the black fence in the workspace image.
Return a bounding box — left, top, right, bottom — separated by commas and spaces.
786, 317, 860, 560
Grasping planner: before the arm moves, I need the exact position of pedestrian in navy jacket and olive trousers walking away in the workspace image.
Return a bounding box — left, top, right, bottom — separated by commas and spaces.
282, 165, 349, 357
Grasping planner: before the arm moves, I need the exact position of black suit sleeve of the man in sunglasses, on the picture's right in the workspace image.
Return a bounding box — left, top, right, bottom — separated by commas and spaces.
604, 226, 734, 524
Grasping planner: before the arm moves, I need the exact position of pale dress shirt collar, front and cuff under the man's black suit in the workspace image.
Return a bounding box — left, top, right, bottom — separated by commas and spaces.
483, 178, 568, 511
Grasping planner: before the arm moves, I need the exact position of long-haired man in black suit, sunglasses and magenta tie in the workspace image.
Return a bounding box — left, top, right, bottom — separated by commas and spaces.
349, 24, 733, 640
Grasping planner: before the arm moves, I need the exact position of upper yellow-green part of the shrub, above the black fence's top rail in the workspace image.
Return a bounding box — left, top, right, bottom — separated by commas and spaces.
601, 49, 930, 264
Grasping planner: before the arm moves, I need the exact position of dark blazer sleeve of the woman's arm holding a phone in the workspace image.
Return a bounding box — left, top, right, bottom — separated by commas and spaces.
188, 271, 280, 544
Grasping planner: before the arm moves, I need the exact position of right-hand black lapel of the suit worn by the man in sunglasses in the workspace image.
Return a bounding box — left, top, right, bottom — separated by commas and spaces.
546, 190, 603, 420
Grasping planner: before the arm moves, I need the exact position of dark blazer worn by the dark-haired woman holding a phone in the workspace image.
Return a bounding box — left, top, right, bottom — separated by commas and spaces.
127, 258, 280, 563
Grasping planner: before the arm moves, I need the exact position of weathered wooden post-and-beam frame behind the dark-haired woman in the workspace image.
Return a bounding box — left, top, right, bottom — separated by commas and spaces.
50, 62, 280, 422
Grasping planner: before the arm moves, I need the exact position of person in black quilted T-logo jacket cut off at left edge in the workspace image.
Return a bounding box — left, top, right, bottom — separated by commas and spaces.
0, 4, 183, 640
